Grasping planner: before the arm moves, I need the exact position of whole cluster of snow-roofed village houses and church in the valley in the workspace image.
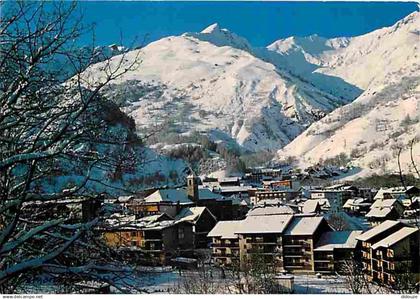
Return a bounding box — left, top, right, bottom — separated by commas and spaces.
96, 169, 420, 290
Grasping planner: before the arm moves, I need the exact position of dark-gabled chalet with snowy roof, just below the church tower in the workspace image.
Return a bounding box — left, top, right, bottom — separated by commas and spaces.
175, 207, 217, 248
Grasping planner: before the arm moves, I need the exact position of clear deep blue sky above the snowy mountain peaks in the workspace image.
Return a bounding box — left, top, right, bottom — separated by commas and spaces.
80, 1, 418, 46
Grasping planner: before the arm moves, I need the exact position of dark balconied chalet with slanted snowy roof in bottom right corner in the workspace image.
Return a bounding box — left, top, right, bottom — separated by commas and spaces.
371, 227, 420, 287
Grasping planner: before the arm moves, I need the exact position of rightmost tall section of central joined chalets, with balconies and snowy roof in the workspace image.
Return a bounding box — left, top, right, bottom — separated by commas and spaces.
283, 215, 332, 273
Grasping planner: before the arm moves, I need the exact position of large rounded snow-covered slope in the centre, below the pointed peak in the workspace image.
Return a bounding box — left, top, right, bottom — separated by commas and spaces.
84, 24, 354, 151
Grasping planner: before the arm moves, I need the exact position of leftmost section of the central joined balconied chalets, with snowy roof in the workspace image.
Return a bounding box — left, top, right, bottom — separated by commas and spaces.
207, 220, 242, 267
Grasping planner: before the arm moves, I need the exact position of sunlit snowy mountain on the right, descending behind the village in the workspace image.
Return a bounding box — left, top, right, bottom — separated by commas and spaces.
276, 12, 420, 175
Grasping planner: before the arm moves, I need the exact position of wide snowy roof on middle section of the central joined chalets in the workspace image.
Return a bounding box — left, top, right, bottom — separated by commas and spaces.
236, 214, 293, 234
